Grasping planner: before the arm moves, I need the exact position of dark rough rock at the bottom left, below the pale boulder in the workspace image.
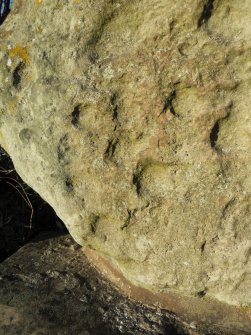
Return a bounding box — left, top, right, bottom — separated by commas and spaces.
0, 236, 194, 335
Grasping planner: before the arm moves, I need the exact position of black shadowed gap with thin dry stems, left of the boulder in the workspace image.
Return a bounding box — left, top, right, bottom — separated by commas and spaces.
0, 147, 66, 262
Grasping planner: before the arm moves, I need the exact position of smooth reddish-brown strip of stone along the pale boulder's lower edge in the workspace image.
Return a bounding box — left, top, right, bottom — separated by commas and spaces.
83, 248, 251, 335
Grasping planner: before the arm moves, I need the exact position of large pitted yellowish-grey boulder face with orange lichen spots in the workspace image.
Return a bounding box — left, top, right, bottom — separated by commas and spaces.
0, 0, 251, 305
